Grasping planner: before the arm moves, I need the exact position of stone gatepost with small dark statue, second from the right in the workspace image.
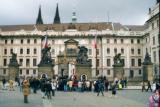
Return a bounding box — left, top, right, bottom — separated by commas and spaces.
113, 53, 124, 80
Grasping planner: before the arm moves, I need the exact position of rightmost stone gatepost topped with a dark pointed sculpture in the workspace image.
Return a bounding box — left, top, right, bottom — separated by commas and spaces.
142, 52, 154, 81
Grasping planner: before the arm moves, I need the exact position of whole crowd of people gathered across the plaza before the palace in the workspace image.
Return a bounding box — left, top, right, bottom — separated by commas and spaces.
2, 76, 160, 107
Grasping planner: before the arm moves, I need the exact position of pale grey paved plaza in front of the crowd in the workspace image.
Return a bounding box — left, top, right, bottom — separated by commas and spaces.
0, 89, 152, 107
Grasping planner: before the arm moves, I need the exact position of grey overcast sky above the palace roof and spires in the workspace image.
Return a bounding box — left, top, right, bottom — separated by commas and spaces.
0, 0, 156, 25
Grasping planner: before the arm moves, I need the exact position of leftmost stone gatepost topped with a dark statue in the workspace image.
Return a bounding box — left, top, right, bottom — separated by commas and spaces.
8, 52, 19, 81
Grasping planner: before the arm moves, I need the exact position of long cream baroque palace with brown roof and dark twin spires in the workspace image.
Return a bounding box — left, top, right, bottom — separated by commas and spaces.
0, 3, 159, 80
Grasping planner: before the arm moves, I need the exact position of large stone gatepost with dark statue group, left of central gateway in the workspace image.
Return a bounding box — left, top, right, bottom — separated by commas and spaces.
38, 47, 54, 78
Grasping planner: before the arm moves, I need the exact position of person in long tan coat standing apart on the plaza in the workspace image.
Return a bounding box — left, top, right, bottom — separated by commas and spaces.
23, 80, 30, 103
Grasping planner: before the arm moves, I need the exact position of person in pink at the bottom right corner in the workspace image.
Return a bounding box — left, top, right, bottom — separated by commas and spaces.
148, 90, 160, 107
